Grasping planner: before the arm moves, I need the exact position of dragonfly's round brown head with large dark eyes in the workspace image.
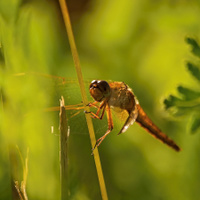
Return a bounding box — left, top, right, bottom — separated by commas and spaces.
90, 80, 111, 102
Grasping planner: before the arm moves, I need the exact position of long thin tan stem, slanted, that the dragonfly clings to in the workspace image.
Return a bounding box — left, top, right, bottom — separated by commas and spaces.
59, 0, 108, 200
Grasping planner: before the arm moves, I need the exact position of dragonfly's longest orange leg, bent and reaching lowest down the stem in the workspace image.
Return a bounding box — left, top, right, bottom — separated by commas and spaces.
92, 103, 113, 151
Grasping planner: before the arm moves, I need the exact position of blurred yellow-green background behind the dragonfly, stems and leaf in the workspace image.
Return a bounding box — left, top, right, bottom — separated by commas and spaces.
0, 0, 200, 200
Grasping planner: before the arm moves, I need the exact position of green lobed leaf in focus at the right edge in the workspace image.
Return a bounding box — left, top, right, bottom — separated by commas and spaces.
164, 38, 200, 133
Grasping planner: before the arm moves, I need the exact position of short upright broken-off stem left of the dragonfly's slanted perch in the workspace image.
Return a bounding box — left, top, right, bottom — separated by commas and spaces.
60, 97, 69, 200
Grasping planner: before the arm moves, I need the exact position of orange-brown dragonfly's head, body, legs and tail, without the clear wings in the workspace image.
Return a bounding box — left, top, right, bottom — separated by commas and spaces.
88, 80, 181, 151
